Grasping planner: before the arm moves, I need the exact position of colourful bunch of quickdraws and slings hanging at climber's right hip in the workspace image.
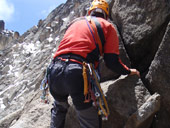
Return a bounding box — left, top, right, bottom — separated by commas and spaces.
83, 62, 110, 120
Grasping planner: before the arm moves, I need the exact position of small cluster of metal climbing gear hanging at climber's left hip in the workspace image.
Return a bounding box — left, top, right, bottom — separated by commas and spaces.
40, 68, 49, 103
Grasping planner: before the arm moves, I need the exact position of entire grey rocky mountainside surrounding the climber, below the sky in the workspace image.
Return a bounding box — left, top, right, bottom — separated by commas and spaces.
0, 0, 170, 128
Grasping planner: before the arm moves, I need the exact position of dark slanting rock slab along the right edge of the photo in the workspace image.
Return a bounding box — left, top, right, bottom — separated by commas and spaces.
146, 23, 170, 128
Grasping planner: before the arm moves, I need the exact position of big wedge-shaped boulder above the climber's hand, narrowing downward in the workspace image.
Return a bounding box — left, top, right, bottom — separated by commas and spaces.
111, 0, 170, 72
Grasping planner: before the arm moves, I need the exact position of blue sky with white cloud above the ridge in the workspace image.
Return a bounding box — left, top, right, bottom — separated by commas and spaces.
0, 0, 66, 35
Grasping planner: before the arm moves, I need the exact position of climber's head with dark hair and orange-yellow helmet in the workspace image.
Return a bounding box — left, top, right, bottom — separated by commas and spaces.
88, 0, 109, 19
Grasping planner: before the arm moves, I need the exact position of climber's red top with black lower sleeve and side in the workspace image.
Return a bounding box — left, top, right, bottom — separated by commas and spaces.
54, 18, 130, 74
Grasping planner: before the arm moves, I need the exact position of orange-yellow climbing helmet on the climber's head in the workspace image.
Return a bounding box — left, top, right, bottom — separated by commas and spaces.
88, 0, 109, 16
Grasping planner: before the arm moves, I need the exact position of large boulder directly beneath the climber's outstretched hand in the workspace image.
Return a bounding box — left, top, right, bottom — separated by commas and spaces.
103, 76, 160, 128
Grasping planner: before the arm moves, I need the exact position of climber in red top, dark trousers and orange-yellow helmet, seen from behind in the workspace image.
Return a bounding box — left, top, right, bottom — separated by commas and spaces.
48, 0, 139, 128
